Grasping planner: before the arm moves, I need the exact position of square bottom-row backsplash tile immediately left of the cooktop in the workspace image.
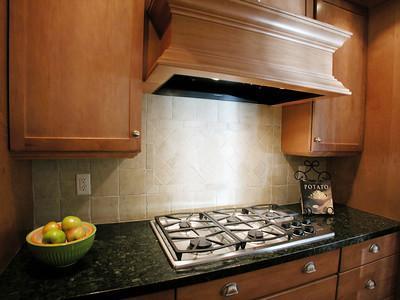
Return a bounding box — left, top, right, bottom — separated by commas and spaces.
119, 195, 146, 221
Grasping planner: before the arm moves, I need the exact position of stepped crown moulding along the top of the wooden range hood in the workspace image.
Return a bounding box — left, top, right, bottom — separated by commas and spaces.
169, 0, 353, 53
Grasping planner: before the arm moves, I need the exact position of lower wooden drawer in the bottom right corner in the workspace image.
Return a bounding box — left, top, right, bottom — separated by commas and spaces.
338, 254, 399, 300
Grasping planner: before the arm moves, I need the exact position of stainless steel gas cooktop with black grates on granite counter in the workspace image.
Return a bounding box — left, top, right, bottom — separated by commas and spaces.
151, 204, 335, 269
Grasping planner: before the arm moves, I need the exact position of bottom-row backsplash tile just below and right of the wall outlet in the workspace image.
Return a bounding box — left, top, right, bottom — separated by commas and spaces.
90, 197, 119, 224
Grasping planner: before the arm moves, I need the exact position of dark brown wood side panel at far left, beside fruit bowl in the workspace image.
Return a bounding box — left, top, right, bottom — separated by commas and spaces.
0, 0, 32, 273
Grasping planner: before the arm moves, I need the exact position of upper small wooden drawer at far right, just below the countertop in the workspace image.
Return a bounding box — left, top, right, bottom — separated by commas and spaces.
340, 233, 400, 272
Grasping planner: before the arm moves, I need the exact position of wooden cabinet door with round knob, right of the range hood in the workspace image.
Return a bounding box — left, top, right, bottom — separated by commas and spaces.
311, 0, 367, 152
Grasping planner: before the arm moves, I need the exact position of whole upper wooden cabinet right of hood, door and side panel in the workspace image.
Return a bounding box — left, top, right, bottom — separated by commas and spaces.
282, 0, 367, 156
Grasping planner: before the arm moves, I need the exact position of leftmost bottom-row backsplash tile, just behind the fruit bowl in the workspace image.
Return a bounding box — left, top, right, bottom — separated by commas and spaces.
33, 196, 61, 227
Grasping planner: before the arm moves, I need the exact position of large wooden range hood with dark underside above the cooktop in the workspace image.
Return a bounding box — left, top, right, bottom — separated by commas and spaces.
144, 0, 351, 104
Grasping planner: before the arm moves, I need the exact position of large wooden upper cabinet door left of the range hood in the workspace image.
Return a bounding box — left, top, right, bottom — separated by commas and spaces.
9, 0, 144, 156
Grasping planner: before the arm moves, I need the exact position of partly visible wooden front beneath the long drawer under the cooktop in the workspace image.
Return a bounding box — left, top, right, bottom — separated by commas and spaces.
262, 275, 337, 300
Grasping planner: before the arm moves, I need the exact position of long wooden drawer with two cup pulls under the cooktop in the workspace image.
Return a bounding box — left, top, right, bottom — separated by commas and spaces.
177, 250, 339, 300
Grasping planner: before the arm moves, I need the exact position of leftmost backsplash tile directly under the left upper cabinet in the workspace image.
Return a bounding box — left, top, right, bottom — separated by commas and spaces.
32, 160, 61, 199
